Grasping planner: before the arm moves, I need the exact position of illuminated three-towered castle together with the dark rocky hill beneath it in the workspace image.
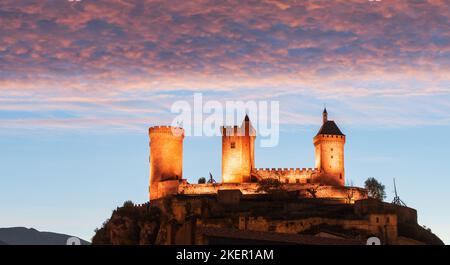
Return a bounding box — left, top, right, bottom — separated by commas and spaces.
93, 109, 443, 245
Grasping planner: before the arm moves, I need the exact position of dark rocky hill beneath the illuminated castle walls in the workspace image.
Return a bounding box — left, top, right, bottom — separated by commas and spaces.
92, 191, 443, 245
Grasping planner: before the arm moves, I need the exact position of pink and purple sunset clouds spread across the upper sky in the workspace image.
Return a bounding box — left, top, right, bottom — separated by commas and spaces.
0, 0, 450, 129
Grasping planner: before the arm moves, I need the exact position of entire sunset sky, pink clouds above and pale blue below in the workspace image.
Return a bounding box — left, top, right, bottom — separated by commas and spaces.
0, 0, 450, 244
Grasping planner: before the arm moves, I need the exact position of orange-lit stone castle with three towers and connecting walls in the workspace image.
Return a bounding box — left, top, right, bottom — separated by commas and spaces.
149, 108, 367, 201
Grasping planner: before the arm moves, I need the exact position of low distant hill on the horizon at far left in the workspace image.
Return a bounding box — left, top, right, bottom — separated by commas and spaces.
0, 227, 90, 245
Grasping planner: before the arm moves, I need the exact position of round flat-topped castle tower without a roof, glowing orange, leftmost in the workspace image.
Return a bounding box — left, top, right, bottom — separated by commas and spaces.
148, 126, 184, 200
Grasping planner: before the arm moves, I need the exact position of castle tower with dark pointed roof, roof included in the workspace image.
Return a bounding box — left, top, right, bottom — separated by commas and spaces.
314, 108, 345, 186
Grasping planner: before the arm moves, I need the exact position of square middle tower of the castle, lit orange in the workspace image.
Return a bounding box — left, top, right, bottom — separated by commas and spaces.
222, 115, 256, 183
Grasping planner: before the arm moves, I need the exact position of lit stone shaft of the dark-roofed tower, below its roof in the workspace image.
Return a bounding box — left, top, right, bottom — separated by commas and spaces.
314, 135, 345, 186
